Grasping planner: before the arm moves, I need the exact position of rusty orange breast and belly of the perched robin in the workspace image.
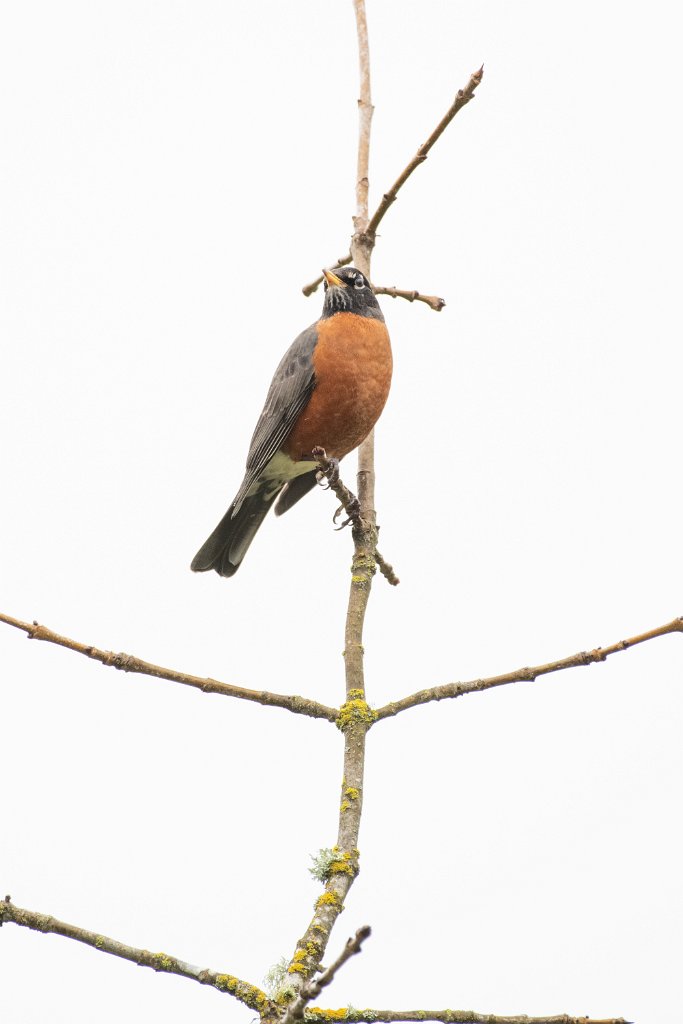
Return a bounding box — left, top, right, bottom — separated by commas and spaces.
283, 313, 392, 460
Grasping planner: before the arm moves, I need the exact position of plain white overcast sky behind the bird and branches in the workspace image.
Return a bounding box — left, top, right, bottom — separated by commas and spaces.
0, 0, 683, 1024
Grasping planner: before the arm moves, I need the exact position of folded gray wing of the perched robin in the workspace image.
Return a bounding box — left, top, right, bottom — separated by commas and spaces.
234, 324, 317, 511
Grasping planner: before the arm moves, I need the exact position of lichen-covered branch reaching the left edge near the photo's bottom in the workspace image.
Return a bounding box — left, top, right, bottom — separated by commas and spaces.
0, 896, 273, 1014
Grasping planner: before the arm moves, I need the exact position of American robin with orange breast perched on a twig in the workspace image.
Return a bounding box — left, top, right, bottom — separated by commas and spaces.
191, 266, 392, 577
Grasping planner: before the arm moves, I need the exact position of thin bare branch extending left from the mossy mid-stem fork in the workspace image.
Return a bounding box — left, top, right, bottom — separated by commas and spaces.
0, 612, 339, 722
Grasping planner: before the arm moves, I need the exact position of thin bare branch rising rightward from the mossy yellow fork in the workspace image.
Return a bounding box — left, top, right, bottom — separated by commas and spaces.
376, 617, 683, 721
